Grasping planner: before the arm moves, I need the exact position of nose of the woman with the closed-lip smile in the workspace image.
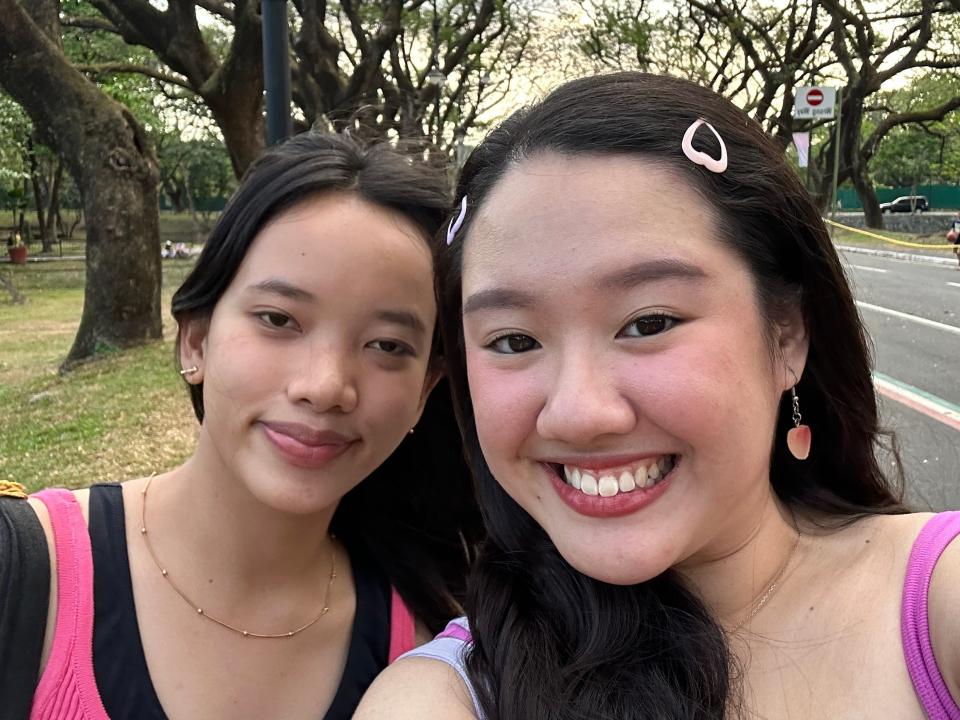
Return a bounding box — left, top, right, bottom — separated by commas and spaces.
287, 343, 360, 413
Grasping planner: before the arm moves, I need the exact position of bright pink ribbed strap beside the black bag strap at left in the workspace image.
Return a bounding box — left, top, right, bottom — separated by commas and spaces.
30, 489, 109, 720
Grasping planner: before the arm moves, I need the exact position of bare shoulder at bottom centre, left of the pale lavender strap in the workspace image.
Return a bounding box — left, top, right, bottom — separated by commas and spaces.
353, 657, 476, 720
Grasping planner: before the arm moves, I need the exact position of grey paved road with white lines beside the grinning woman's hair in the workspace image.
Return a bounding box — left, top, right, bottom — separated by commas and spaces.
841, 253, 960, 510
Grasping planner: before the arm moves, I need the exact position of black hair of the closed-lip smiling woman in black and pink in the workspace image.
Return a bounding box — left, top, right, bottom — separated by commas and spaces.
172, 131, 481, 632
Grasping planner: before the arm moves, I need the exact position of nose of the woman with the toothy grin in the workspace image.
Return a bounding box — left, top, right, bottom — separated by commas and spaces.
537, 349, 637, 447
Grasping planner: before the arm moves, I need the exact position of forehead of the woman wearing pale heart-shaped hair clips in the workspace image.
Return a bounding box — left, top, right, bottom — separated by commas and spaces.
463, 154, 736, 292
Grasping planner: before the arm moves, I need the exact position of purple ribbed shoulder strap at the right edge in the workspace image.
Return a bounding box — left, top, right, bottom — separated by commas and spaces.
900, 512, 960, 720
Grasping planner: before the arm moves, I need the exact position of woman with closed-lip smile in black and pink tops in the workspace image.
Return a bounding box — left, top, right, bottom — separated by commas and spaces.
0, 132, 479, 720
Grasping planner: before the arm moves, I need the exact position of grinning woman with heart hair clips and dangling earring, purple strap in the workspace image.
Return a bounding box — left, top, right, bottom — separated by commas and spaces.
356, 73, 960, 720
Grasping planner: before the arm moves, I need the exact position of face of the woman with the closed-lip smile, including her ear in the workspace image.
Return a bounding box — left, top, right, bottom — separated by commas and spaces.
181, 193, 436, 513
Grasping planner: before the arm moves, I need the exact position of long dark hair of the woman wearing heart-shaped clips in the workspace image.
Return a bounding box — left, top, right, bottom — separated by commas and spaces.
438, 73, 905, 720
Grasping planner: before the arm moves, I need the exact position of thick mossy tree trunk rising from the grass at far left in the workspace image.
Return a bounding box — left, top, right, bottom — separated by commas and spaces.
0, 0, 161, 369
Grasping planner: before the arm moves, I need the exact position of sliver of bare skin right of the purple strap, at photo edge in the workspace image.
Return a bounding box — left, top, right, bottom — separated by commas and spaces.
927, 512, 960, 702
